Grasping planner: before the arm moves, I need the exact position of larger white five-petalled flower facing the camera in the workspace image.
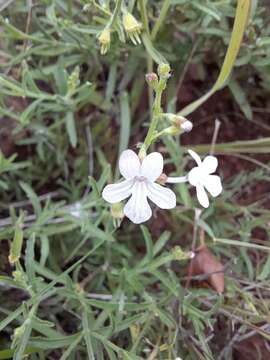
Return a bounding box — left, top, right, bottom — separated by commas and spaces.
102, 150, 176, 224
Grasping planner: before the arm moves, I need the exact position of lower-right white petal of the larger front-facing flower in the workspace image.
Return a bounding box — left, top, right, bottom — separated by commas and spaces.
147, 182, 176, 209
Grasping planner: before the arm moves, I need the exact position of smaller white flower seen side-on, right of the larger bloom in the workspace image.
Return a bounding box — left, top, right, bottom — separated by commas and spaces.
188, 150, 222, 208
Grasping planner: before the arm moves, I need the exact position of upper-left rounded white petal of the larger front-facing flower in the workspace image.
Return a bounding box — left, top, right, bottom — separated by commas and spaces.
119, 150, 141, 179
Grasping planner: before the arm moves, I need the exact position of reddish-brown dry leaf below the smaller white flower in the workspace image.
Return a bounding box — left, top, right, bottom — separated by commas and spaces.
188, 245, 224, 294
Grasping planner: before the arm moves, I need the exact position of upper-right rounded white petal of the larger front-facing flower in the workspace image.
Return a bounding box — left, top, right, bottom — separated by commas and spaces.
141, 152, 163, 182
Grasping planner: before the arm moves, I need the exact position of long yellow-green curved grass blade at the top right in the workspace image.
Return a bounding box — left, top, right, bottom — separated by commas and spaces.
179, 0, 251, 116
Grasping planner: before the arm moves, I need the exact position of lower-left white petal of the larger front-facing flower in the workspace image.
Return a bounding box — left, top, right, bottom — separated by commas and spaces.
102, 180, 134, 204
